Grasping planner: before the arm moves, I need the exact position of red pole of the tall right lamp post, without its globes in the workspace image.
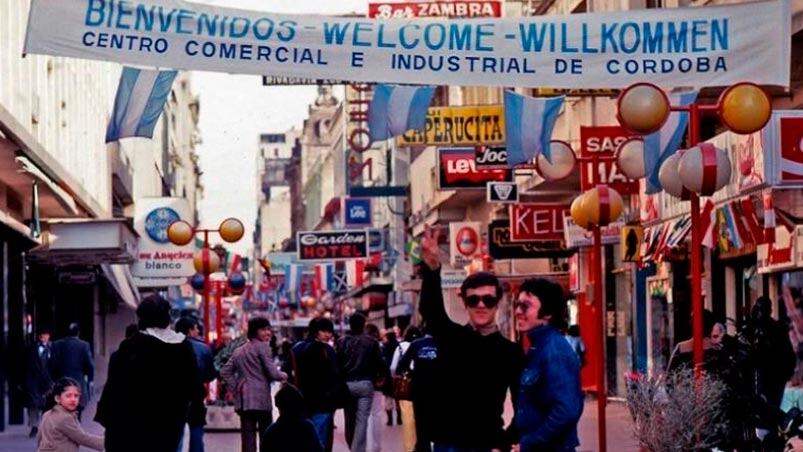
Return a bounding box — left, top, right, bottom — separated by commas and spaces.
689, 103, 704, 377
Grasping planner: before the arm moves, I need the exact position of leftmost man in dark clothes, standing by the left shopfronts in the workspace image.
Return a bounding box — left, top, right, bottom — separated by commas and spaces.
25, 328, 53, 438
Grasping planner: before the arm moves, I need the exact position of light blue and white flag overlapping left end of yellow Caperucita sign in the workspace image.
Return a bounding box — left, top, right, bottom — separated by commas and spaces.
368, 84, 435, 143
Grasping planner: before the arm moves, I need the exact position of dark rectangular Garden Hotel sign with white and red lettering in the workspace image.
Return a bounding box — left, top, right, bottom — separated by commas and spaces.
298, 230, 368, 261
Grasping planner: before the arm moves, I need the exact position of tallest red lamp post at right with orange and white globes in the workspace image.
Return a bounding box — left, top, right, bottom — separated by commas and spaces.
617, 82, 772, 376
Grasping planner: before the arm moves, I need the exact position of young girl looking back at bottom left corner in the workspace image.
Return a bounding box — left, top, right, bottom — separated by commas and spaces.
36, 377, 103, 452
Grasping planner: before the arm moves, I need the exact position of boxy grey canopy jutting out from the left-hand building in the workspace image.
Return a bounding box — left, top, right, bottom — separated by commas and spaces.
30, 218, 137, 265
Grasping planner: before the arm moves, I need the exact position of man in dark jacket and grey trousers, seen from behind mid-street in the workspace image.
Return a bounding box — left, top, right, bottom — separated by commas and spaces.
336, 313, 385, 452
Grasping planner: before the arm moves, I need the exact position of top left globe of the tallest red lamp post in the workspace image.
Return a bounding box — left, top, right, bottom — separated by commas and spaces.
616, 83, 671, 135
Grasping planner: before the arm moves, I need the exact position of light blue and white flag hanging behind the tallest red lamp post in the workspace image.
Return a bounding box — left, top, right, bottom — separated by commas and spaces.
644, 91, 697, 195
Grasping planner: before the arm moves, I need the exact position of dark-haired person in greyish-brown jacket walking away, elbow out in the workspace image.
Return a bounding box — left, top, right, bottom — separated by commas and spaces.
220, 317, 287, 452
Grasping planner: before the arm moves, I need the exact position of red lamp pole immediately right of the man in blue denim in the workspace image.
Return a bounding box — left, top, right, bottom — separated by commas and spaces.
591, 225, 608, 452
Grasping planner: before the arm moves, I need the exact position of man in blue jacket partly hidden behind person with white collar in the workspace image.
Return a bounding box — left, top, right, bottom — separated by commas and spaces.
176, 317, 217, 452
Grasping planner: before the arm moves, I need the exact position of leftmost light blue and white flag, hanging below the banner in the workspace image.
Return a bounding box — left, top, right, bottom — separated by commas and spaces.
106, 67, 178, 143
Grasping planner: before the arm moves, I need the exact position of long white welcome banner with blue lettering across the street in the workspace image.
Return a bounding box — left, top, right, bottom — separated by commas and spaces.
25, 0, 791, 89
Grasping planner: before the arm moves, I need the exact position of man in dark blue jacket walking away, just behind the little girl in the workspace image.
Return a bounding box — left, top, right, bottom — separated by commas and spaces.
50, 323, 95, 419
